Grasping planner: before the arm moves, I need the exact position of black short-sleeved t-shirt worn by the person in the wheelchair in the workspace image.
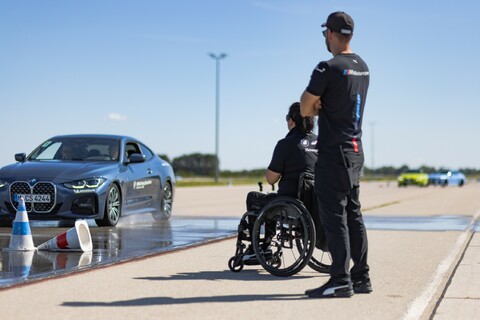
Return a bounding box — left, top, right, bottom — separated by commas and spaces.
268, 128, 317, 198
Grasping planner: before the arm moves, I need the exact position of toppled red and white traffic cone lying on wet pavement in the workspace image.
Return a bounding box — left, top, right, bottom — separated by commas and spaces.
37, 220, 93, 252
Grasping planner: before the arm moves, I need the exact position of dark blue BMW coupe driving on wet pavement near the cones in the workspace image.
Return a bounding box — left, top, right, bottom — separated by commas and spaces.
0, 135, 175, 226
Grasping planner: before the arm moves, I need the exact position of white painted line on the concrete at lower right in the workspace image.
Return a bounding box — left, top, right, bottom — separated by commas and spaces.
403, 210, 480, 320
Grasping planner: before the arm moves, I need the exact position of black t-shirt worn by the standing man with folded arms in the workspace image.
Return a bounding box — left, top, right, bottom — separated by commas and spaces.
307, 53, 370, 153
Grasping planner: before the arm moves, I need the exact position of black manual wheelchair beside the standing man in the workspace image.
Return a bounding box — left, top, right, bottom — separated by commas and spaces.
228, 174, 331, 277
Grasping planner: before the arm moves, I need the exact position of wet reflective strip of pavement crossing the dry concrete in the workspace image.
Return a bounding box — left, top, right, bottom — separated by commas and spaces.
0, 215, 480, 289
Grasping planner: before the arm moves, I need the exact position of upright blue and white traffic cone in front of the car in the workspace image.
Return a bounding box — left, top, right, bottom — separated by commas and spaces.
7, 198, 35, 251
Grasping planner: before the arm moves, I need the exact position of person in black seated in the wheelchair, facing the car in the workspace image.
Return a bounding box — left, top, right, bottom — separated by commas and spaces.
243, 102, 317, 265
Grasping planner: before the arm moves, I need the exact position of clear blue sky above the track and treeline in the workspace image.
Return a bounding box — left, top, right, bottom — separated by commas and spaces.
0, 0, 480, 170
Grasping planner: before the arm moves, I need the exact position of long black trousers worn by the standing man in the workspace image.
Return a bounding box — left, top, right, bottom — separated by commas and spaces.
315, 151, 370, 282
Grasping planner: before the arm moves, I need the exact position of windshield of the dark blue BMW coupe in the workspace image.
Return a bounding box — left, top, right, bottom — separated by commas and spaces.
28, 137, 120, 161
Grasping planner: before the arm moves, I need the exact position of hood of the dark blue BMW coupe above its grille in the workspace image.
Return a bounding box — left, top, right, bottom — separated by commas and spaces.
0, 161, 119, 181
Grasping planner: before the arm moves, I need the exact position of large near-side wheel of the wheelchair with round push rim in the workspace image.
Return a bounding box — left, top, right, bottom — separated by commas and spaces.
252, 197, 315, 277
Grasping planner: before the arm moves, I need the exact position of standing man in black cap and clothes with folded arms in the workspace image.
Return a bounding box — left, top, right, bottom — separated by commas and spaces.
301, 12, 372, 298
